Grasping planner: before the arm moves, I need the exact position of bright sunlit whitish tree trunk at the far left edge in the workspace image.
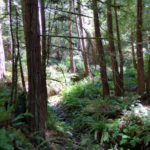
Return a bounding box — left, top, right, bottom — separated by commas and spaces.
0, 24, 5, 79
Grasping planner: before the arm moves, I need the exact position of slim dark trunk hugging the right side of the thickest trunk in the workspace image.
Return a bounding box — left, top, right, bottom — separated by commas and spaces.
40, 0, 47, 123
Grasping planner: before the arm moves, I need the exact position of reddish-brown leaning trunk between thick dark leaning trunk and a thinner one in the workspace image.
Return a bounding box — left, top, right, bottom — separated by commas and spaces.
107, 0, 122, 96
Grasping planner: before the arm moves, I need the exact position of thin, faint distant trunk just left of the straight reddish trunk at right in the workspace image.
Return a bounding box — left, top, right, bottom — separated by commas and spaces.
130, 33, 137, 69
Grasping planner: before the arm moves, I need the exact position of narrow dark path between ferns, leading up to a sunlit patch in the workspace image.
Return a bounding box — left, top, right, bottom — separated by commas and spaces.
48, 95, 82, 150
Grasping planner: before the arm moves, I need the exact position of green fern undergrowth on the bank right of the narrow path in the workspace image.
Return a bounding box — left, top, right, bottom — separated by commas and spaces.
62, 76, 150, 150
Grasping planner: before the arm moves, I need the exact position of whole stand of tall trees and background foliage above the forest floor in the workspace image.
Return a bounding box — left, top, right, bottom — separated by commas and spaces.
0, 0, 150, 148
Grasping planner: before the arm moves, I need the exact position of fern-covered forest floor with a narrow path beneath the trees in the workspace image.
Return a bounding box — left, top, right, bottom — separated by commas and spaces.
0, 68, 150, 150
